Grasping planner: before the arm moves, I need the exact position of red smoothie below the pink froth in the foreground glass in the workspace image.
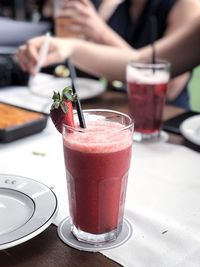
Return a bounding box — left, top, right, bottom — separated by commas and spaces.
64, 144, 131, 234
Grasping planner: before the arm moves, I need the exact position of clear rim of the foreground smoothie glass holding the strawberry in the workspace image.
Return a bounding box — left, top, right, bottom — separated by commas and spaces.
63, 108, 134, 133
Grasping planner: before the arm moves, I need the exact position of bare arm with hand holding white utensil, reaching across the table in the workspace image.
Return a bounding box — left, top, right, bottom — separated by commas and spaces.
17, 16, 200, 80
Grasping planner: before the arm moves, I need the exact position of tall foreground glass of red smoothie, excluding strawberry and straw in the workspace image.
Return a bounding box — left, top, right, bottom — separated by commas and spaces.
63, 109, 133, 244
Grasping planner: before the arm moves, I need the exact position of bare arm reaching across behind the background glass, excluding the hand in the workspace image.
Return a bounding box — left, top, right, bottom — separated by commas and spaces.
61, 16, 200, 80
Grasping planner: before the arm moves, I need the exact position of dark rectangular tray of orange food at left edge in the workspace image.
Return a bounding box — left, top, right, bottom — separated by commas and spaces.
0, 102, 48, 143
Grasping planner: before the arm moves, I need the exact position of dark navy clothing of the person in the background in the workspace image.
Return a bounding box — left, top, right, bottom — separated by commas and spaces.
93, 0, 189, 109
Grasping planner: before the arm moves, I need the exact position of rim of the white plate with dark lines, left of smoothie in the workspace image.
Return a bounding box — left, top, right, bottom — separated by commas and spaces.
0, 173, 58, 250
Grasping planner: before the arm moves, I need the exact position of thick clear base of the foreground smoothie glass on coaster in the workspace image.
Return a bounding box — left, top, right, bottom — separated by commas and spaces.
71, 225, 122, 244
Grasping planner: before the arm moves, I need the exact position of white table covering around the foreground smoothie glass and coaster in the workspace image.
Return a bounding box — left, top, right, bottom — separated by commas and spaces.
0, 106, 200, 267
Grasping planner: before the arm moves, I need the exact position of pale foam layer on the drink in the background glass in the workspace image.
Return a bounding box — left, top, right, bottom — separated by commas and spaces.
127, 67, 169, 84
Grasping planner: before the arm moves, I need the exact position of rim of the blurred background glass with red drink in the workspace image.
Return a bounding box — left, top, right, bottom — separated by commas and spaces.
127, 58, 171, 69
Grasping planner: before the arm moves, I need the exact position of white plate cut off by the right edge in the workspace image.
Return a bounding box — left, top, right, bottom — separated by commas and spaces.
180, 115, 200, 146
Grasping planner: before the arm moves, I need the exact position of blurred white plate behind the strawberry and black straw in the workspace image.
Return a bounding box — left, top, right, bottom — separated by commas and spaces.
30, 73, 106, 100
